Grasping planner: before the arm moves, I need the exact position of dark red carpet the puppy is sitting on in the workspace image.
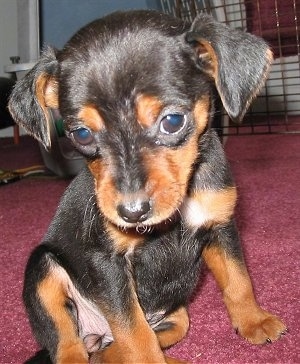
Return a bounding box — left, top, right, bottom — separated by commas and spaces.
0, 135, 300, 364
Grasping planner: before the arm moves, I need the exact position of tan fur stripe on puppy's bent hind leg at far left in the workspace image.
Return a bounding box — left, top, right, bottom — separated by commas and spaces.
38, 272, 88, 364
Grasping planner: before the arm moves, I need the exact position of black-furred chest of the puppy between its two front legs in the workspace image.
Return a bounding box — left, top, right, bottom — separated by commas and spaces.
127, 232, 202, 314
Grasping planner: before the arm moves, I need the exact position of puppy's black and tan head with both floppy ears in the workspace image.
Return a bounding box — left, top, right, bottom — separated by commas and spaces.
9, 11, 272, 228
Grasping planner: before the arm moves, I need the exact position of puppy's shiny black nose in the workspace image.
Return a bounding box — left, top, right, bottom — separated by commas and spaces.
117, 198, 151, 223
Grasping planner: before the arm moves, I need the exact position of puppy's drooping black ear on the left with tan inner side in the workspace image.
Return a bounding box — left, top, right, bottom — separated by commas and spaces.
8, 48, 59, 148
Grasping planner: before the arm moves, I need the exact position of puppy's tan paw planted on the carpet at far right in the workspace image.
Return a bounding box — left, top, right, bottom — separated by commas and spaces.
236, 308, 287, 344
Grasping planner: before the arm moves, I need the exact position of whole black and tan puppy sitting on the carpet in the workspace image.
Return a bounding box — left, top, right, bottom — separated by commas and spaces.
9, 11, 286, 364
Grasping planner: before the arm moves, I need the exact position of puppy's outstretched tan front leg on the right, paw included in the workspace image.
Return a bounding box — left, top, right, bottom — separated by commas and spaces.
202, 221, 286, 344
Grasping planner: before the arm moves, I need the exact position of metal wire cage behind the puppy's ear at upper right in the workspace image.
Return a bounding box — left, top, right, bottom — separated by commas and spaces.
161, 0, 300, 135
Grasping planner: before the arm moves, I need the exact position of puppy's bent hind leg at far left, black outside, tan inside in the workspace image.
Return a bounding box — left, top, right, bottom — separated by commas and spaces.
23, 245, 88, 364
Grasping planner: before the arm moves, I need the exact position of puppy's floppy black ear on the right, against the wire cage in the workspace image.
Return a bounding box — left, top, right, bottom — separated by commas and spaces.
186, 14, 273, 121
